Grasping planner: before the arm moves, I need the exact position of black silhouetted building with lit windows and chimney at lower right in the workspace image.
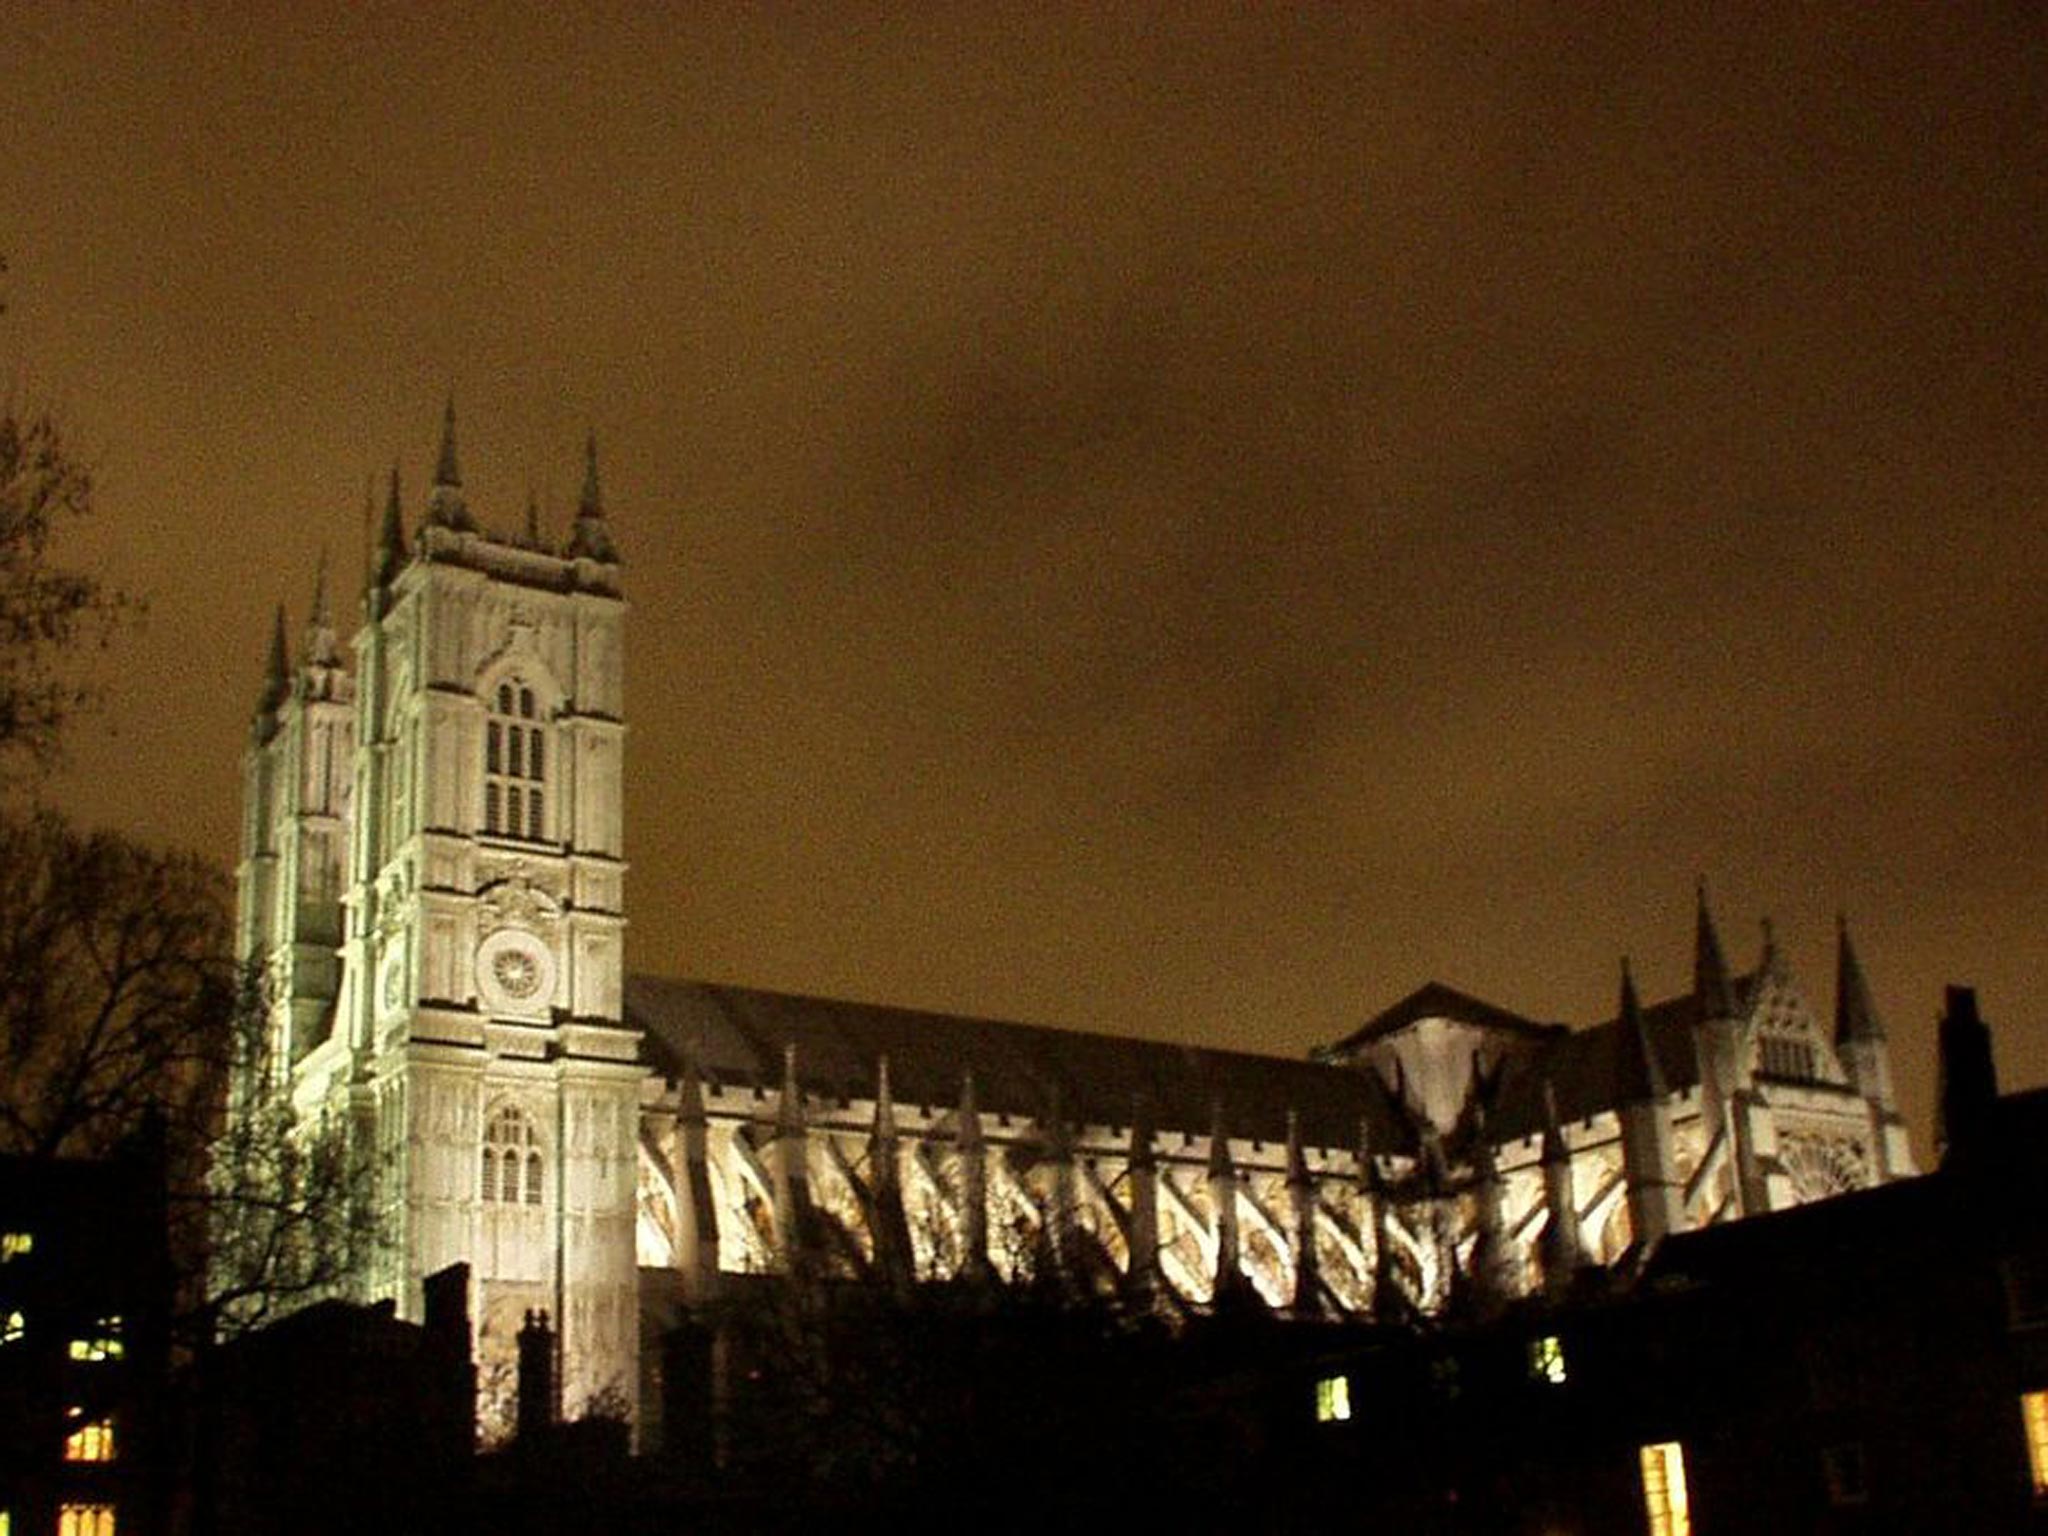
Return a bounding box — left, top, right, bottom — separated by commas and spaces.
1274, 989, 2048, 1536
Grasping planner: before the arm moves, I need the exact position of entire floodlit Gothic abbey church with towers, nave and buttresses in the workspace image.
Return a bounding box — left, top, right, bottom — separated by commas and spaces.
240, 412, 1913, 1434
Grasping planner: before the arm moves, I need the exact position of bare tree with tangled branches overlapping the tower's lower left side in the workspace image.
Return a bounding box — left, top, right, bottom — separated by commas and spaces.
0, 811, 379, 1343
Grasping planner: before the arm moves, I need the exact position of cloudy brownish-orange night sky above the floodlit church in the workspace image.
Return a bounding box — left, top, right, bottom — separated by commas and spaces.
0, 0, 2048, 1147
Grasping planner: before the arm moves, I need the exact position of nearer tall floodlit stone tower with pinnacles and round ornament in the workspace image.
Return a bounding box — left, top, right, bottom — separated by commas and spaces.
242, 406, 645, 1417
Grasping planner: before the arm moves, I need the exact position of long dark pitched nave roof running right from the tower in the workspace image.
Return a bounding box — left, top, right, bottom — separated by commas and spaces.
627, 977, 1413, 1153
